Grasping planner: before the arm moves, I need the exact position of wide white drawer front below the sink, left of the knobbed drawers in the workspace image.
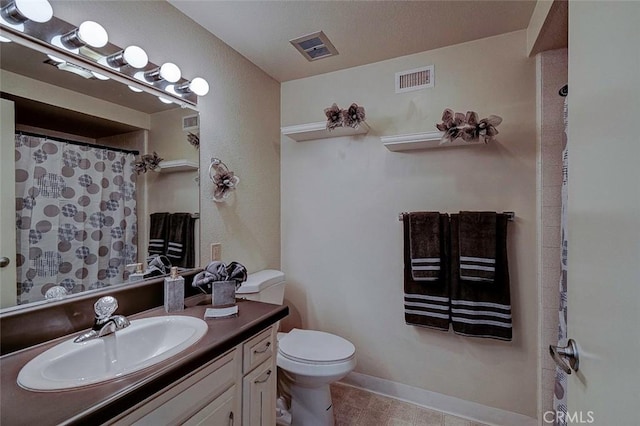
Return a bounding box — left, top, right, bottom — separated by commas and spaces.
115, 349, 240, 426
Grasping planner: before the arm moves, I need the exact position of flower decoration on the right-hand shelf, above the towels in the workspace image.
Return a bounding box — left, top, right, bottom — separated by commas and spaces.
436, 108, 502, 145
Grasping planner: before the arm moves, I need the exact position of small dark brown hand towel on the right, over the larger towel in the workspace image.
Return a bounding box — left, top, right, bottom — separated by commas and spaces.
453, 212, 496, 283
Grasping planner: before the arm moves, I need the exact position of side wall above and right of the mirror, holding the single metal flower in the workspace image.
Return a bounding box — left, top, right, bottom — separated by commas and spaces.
52, 0, 280, 271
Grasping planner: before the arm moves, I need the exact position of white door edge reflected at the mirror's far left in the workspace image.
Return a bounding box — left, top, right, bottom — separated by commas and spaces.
0, 99, 17, 308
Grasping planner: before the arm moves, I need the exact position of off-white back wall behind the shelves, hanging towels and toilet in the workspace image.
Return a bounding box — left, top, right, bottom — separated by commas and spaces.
281, 31, 538, 417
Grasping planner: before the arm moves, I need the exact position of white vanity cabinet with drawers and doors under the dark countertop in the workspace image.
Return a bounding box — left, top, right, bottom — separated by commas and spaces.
108, 326, 276, 426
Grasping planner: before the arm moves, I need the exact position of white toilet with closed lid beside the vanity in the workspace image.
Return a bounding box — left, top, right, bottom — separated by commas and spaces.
236, 269, 356, 426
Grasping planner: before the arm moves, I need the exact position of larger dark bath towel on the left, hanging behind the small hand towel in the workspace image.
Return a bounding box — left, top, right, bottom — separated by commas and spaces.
403, 212, 450, 331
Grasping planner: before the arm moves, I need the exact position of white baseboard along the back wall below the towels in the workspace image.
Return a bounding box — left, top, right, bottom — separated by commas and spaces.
340, 372, 538, 426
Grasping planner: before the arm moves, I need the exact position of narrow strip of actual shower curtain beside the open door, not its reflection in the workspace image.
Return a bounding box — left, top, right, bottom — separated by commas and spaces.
553, 97, 569, 426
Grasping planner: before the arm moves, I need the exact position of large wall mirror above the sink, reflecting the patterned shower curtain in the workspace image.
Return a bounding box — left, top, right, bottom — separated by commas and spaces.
0, 31, 199, 309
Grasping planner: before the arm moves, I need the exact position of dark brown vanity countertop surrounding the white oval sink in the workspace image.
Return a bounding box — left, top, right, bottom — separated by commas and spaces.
0, 295, 289, 425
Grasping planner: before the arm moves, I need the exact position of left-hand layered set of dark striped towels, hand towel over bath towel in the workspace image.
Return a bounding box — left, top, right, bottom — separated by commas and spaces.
403, 212, 450, 331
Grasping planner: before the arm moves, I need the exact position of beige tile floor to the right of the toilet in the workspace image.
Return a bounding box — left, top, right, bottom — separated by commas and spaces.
331, 383, 486, 426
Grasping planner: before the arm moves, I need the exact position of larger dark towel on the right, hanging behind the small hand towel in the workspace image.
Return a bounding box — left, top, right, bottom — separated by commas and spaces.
450, 214, 512, 340
